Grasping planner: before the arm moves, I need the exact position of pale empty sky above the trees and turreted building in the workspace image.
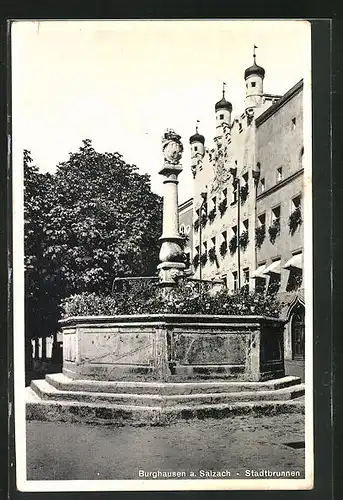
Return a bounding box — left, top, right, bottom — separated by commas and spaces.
12, 20, 310, 202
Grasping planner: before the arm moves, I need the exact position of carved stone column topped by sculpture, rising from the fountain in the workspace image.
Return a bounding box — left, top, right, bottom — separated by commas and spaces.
158, 129, 186, 287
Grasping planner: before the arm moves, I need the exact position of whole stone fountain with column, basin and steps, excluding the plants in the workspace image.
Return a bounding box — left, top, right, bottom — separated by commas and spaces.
26, 130, 304, 425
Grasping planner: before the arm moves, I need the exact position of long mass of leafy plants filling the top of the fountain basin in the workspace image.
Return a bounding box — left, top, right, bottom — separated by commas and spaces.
63, 280, 282, 317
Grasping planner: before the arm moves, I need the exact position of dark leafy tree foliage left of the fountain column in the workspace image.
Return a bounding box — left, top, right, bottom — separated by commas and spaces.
24, 139, 162, 336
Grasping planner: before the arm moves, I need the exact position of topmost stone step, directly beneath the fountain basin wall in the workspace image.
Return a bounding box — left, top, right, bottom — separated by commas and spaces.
46, 373, 301, 396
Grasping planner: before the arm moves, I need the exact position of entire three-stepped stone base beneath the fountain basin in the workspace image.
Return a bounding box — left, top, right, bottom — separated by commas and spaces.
26, 374, 305, 425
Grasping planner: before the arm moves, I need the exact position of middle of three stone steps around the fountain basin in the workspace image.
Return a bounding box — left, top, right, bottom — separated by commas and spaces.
31, 380, 305, 407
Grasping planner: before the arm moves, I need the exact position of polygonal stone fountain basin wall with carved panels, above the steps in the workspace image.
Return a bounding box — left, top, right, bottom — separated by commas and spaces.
60, 314, 285, 382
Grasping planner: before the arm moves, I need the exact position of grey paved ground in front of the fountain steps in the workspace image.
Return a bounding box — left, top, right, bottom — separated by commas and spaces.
27, 414, 304, 480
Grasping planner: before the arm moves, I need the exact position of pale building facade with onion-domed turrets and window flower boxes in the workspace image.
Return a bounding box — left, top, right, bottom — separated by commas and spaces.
179, 54, 305, 359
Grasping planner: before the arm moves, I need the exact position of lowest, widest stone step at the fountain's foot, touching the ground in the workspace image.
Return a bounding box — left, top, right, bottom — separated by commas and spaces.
25, 387, 305, 426
